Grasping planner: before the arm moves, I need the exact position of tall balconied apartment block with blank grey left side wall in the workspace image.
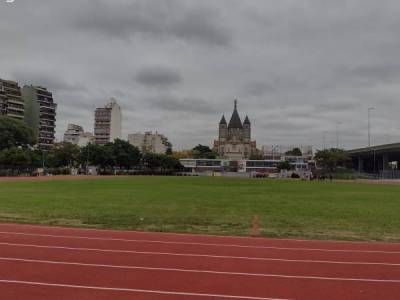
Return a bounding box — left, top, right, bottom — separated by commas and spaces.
22, 85, 57, 150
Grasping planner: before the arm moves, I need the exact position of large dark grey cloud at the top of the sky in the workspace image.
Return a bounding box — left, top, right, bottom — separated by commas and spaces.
74, 0, 231, 46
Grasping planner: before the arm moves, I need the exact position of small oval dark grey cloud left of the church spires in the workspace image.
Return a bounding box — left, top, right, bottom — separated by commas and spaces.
135, 66, 183, 87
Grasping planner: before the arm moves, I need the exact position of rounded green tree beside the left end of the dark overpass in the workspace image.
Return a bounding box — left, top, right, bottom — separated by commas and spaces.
315, 148, 350, 172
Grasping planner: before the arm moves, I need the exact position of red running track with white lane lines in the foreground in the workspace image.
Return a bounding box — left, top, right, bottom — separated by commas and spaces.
0, 224, 400, 300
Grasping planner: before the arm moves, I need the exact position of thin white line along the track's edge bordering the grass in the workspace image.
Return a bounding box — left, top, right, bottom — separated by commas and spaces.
0, 223, 384, 245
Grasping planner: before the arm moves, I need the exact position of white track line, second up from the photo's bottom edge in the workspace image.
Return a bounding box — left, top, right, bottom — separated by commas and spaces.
0, 257, 400, 283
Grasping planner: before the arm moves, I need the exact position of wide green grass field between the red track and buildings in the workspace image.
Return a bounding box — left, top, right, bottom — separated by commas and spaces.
0, 177, 400, 241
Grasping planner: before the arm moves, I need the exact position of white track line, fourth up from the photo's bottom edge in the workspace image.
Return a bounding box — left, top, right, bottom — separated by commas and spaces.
0, 231, 400, 254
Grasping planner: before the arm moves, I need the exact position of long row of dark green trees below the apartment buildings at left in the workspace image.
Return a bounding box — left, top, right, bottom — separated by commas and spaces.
0, 117, 182, 175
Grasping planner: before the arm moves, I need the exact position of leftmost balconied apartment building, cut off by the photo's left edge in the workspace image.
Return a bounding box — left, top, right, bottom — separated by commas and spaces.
0, 79, 25, 120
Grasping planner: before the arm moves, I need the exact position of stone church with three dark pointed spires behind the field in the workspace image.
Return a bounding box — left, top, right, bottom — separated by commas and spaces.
214, 100, 257, 160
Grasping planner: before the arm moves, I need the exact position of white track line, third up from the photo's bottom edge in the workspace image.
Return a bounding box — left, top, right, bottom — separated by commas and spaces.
0, 242, 400, 267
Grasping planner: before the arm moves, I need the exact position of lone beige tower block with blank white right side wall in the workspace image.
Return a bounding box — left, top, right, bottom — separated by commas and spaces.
94, 98, 122, 145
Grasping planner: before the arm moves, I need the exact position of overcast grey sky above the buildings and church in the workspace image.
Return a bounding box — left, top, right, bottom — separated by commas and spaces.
0, 0, 400, 149
